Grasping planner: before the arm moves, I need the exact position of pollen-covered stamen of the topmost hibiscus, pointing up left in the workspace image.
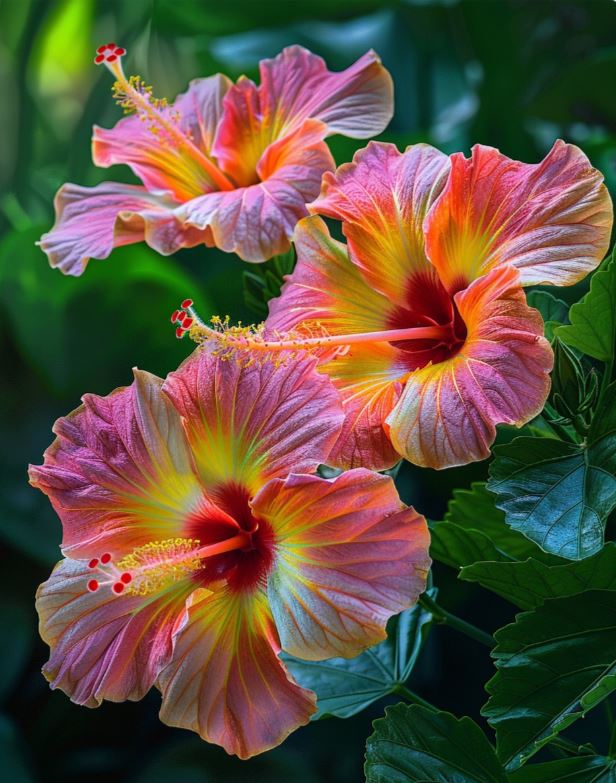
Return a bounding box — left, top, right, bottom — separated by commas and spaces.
94, 43, 234, 190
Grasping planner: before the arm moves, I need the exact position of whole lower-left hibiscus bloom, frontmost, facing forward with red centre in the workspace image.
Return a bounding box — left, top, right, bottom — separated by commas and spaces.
30, 349, 430, 758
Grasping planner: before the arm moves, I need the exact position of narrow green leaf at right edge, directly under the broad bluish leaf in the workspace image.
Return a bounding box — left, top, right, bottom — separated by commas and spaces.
460, 543, 616, 609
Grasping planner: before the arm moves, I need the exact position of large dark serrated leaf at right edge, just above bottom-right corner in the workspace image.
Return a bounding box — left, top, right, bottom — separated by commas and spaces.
482, 590, 616, 771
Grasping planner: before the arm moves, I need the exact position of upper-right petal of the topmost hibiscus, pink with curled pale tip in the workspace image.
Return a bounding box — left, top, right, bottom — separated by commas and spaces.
213, 46, 393, 185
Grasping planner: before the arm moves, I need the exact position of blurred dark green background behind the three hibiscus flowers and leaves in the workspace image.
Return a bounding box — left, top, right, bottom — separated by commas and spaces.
0, 0, 616, 783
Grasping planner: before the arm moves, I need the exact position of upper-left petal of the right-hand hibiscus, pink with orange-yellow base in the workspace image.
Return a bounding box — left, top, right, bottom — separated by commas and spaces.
309, 142, 448, 308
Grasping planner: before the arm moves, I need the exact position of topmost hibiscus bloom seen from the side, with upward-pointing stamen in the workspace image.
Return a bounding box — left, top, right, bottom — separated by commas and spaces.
40, 44, 393, 275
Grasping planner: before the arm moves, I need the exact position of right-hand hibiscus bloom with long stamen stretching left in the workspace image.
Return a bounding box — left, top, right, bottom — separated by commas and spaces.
188, 141, 612, 470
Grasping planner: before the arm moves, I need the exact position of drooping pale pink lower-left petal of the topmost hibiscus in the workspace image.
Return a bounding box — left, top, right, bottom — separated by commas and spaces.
40, 182, 211, 276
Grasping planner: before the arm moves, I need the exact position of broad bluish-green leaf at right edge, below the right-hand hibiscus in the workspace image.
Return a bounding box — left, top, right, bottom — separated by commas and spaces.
488, 384, 616, 560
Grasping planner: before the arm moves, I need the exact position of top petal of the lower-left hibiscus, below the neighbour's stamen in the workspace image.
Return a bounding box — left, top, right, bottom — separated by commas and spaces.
163, 347, 342, 493
